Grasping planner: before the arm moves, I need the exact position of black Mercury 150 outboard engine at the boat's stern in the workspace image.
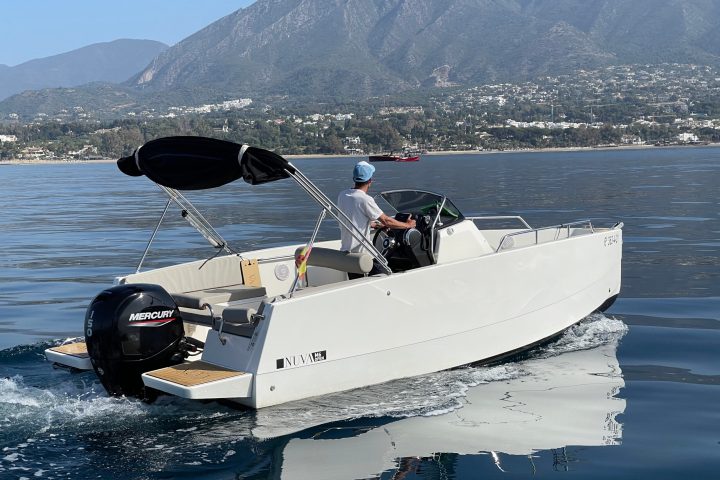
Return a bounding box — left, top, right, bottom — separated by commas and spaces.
85, 283, 183, 399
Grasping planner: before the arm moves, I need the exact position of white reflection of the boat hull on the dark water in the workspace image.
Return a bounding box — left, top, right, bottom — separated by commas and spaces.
281, 330, 625, 479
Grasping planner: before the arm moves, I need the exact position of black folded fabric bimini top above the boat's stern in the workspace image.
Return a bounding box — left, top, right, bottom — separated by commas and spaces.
117, 137, 295, 190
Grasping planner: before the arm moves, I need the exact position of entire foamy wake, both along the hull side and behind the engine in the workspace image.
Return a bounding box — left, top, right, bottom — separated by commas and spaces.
0, 314, 627, 478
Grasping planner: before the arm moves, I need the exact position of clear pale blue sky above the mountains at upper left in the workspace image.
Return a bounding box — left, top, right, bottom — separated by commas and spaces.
0, 0, 255, 66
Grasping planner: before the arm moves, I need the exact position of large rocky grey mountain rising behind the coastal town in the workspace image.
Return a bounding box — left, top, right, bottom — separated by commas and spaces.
0, 0, 720, 113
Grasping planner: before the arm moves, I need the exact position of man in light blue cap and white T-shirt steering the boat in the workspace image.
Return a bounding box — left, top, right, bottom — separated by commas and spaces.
337, 161, 415, 278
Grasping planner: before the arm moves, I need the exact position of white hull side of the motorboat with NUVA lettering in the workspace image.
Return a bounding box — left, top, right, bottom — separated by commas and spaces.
203, 229, 622, 408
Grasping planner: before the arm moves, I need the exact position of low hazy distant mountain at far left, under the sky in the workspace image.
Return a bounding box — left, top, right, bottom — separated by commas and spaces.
0, 40, 168, 100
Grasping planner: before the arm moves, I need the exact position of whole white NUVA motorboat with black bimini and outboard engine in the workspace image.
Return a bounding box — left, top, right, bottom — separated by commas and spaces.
46, 137, 622, 408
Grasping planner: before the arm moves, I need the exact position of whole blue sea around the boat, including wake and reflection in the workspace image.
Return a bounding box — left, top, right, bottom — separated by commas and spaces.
0, 148, 720, 480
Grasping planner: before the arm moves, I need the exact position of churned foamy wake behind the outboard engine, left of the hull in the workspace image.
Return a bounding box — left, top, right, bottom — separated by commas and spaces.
0, 342, 250, 478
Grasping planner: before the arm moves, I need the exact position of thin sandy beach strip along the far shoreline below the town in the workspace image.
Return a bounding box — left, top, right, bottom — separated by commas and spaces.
0, 143, 720, 165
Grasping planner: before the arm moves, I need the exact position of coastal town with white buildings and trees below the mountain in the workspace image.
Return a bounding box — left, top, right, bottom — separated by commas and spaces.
0, 64, 720, 161
